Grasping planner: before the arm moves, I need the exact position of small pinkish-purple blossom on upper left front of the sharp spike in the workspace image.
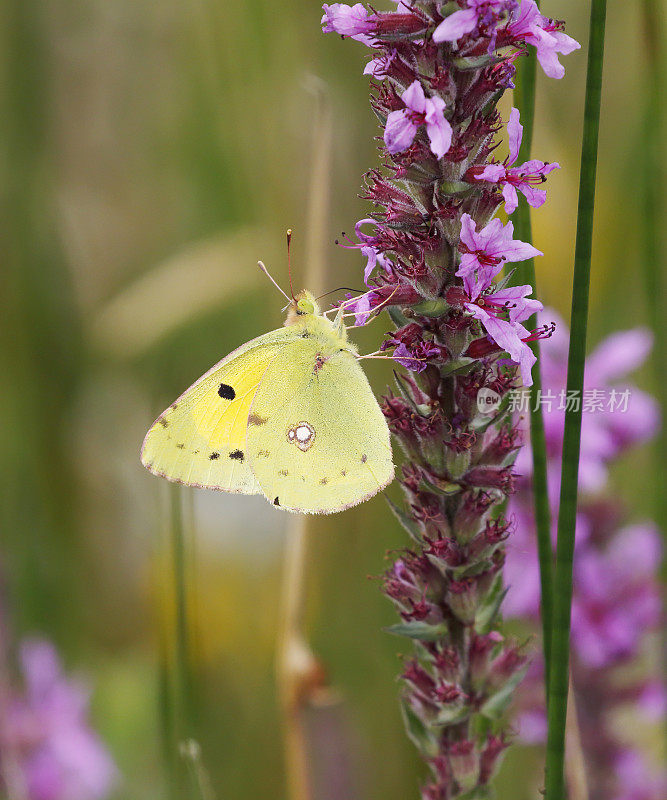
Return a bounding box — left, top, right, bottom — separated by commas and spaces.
384, 81, 452, 158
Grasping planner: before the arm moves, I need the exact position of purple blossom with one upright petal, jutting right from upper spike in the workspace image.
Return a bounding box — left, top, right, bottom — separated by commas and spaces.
466, 108, 560, 214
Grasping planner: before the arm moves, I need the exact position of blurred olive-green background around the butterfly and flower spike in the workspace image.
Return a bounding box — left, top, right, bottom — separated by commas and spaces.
0, 0, 660, 800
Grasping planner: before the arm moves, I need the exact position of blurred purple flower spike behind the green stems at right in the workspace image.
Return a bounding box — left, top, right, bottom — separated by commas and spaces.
504, 312, 667, 800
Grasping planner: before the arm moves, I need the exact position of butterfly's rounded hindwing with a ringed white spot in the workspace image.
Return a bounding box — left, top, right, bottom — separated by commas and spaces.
246, 335, 394, 514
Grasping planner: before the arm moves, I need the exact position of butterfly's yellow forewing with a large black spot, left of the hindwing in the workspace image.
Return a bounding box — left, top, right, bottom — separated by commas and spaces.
141, 328, 293, 494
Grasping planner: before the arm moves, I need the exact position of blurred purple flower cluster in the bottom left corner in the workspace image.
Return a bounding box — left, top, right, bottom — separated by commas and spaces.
0, 640, 117, 800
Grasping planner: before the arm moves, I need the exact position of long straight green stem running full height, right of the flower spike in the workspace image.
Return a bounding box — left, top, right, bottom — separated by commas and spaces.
545, 0, 607, 800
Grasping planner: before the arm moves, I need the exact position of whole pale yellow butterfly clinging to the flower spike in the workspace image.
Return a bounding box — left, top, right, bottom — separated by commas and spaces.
141, 292, 394, 514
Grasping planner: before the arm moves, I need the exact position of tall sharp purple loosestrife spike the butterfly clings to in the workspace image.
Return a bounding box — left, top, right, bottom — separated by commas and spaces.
324, 0, 580, 800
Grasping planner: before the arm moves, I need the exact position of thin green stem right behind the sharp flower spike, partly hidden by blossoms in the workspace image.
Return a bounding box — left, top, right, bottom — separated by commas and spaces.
515, 23, 553, 696
